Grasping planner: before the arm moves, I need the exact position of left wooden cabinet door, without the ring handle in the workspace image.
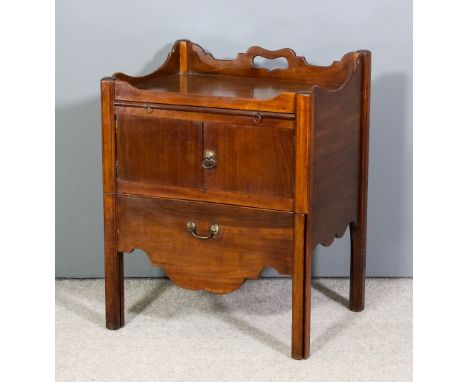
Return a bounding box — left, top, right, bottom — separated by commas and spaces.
117, 114, 203, 188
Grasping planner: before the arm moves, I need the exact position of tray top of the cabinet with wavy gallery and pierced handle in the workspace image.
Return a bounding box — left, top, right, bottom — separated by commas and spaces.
108, 40, 361, 112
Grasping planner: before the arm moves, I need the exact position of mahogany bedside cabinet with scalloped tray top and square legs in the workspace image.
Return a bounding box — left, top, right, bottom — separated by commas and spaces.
101, 40, 370, 359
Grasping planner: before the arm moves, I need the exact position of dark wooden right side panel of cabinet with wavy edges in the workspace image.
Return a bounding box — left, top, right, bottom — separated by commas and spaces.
309, 60, 362, 246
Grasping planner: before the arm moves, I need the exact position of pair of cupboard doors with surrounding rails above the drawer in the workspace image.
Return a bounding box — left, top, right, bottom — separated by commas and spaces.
116, 107, 295, 211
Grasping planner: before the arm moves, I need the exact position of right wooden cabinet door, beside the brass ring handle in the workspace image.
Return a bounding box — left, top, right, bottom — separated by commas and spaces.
203, 122, 294, 198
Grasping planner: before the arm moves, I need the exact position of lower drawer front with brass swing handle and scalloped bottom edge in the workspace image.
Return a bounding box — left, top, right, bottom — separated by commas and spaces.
116, 195, 294, 293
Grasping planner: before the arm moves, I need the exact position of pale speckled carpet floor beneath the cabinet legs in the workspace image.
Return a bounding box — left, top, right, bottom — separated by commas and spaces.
56, 279, 412, 382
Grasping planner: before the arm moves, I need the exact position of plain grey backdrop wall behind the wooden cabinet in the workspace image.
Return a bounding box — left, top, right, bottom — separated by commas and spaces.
56, 0, 412, 277
